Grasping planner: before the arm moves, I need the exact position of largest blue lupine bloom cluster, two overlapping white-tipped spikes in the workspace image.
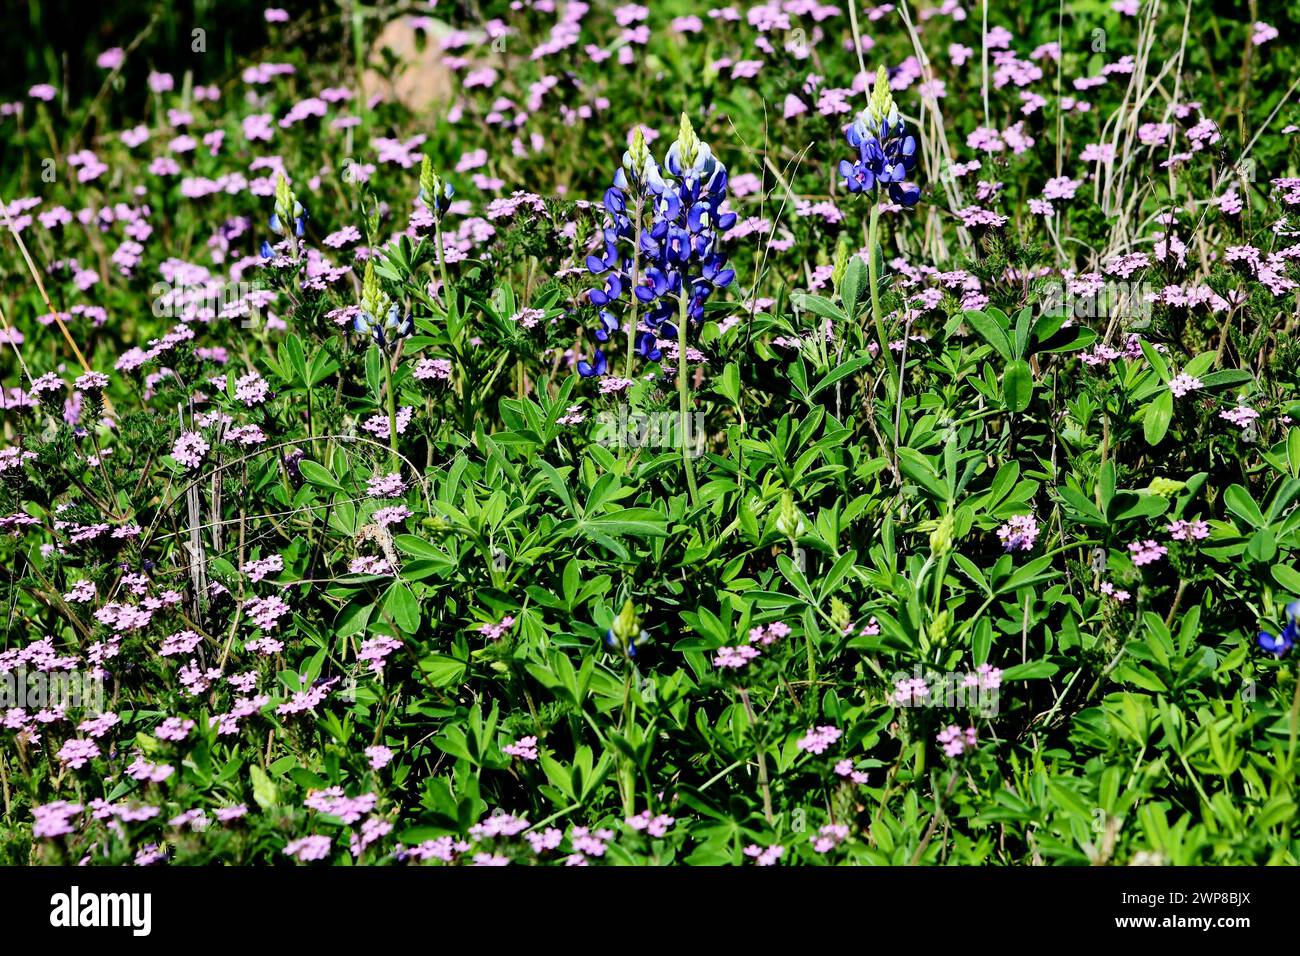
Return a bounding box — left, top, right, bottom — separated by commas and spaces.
577, 114, 736, 376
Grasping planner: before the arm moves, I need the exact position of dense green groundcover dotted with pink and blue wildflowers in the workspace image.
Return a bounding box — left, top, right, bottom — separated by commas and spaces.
0, 0, 1300, 866
